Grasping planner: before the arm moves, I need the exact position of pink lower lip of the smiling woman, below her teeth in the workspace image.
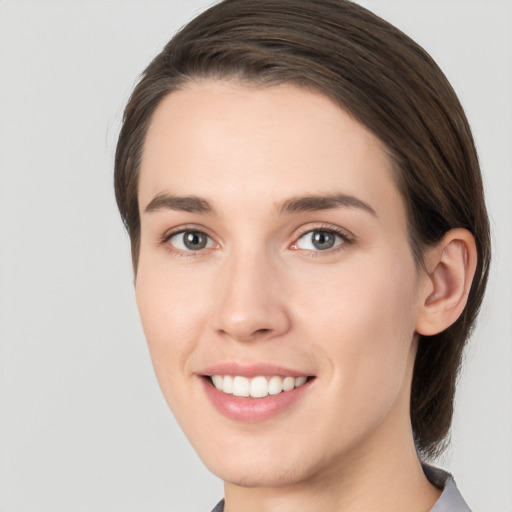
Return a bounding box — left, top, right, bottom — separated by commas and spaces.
201, 378, 312, 423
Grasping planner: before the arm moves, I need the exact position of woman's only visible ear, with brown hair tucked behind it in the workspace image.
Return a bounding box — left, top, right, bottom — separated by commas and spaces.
416, 228, 477, 336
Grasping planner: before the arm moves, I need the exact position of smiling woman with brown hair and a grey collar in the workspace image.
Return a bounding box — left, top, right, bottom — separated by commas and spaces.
115, 0, 490, 512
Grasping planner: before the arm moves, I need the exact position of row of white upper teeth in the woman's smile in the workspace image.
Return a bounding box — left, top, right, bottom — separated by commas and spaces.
211, 375, 307, 398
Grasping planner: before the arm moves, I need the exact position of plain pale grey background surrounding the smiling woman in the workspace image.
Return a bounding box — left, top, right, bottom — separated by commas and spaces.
0, 0, 512, 512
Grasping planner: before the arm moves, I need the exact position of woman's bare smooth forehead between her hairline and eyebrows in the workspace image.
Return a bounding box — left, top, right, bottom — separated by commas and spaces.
139, 81, 401, 228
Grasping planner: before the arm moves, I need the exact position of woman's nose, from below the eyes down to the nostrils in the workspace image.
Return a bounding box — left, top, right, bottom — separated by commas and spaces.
214, 251, 291, 342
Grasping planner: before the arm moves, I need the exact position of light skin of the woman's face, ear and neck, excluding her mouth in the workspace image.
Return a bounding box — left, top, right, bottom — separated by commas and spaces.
136, 81, 476, 512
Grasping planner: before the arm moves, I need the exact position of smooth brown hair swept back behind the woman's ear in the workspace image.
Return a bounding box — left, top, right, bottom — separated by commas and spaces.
115, 0, 490, 457
